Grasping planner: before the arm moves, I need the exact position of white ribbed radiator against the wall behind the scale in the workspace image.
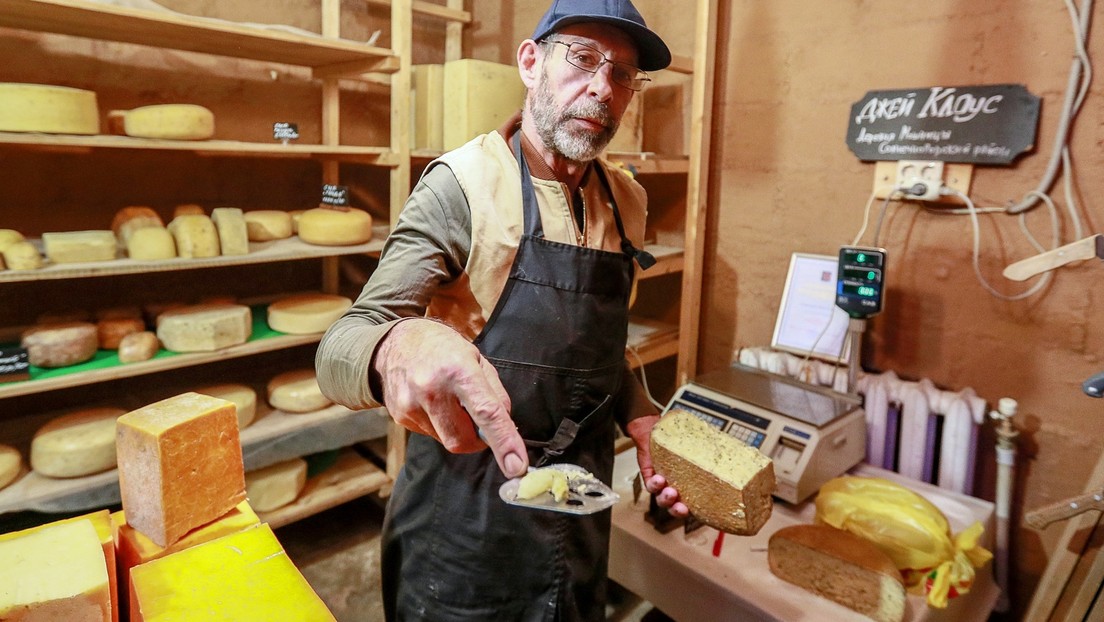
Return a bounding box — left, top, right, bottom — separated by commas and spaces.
736, 348, 986, 495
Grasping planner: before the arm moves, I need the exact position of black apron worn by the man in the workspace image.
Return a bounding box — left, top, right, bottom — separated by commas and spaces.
382, 137, 650, 622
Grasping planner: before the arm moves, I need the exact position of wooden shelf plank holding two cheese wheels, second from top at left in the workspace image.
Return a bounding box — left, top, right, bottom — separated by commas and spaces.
0, 132, 397, 167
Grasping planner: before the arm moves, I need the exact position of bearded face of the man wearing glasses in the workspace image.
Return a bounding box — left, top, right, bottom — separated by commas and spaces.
530, 24, 636, 162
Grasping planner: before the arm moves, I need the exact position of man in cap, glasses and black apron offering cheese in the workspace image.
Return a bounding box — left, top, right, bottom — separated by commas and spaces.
316, 0, 687, 622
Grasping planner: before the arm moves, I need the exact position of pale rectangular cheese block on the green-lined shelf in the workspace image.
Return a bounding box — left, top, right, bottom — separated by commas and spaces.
157, 304, 253, 352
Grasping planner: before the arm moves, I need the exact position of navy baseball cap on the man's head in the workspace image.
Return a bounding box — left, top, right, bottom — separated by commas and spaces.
533, 0, 671, 72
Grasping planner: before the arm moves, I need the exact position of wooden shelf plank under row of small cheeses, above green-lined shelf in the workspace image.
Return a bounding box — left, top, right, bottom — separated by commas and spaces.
0, 225, 388, 284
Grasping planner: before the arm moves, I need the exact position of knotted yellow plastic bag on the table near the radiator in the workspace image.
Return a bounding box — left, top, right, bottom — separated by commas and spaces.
816, 475, 992, 608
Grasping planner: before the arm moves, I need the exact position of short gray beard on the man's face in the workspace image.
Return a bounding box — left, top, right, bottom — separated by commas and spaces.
530, 74, 619, 162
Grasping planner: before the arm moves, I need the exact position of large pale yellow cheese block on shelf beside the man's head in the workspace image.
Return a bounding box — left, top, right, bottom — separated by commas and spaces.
443, 59, 526, 151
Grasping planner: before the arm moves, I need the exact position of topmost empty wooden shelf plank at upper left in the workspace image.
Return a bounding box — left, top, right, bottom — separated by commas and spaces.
0, 0, 393, 73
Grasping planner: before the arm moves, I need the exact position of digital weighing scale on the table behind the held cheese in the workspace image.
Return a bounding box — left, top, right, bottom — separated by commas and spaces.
666, 365, 867, 504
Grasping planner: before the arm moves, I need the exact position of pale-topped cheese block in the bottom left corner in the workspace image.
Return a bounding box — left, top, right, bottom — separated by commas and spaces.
0, 518, 113, 622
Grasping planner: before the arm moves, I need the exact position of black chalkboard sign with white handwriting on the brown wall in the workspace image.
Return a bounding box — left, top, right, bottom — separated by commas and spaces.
847, 84, 1039, 165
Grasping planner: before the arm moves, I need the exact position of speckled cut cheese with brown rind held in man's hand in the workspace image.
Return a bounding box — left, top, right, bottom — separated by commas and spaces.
651, 409, 775, 536
